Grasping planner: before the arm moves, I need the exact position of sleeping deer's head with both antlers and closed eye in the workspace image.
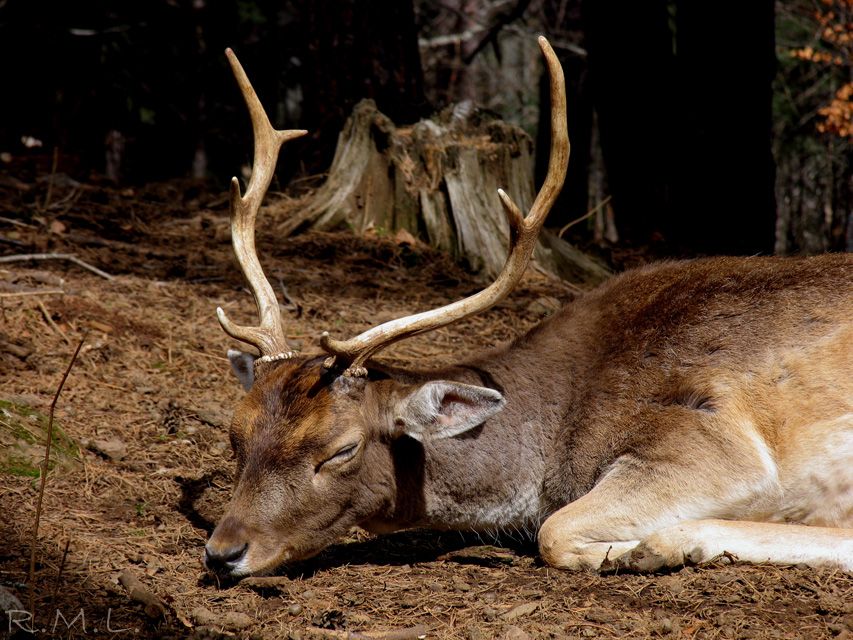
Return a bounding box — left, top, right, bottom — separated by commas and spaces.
205, 38, 569, 576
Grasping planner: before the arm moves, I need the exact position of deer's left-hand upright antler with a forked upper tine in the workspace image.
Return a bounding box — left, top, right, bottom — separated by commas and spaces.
216, 49, 308, 361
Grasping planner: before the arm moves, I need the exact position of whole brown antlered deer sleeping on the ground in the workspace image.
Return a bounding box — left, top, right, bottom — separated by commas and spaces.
205, 39, 853, 576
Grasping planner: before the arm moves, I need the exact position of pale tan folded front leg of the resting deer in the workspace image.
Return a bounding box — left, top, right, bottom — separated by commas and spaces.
539, 452, 853, 571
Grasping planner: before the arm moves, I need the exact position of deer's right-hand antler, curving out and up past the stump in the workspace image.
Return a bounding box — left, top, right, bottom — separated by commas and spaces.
320, 37, 570, 376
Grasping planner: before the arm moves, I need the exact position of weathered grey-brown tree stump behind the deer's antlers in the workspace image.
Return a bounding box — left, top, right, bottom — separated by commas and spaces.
280, 100, 609, 284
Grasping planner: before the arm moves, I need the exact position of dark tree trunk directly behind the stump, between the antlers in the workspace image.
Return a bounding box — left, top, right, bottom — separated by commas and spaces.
300, 0, 426, 171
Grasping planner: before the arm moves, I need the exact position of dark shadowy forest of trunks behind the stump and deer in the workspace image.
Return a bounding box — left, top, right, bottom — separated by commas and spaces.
0, 0, 853, 254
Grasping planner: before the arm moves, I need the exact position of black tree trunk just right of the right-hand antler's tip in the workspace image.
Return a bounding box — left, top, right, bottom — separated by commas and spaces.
583, 0, 673, 242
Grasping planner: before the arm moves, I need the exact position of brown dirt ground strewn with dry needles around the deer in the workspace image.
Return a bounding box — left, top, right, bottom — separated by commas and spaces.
0, 163, 853, 640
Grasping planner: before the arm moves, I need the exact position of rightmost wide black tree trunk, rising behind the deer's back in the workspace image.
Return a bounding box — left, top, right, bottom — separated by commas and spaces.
671, 0, 776, 254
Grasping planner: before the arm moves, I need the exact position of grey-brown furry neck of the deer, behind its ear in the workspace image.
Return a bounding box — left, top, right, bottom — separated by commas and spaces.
364, 350, 565, 534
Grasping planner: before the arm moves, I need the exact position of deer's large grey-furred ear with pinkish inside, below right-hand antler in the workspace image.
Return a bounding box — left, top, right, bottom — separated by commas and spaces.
393, 380, 506, 442
